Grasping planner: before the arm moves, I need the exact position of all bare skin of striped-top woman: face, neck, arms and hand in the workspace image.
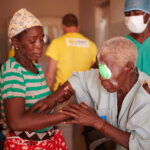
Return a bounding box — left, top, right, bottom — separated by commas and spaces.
4, 26, 72, 131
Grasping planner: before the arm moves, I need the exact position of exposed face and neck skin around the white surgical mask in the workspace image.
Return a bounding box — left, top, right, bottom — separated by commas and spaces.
125, 10, 150, 44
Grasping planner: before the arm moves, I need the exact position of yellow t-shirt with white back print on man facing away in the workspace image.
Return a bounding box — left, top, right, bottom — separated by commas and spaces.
46, 33, 97, 90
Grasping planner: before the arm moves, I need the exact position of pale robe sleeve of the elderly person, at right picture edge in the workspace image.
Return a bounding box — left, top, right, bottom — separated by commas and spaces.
127, 88, 150, 150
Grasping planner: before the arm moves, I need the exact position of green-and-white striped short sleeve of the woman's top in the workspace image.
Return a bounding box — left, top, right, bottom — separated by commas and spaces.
1, 69, 26, 100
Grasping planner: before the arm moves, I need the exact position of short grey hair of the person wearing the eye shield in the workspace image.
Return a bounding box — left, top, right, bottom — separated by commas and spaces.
97, 36, 137, 67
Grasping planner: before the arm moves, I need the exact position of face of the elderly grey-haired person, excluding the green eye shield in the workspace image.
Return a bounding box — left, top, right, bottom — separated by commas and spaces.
99, 55, 126, 92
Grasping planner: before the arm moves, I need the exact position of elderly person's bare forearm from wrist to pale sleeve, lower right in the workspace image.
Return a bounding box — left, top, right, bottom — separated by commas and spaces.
93, 119, 130, 149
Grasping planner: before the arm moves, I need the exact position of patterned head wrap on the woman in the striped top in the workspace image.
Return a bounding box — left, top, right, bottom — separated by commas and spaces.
8, 8, 42, 39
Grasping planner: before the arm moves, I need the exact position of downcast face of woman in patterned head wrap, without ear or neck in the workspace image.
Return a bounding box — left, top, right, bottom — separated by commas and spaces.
15, 26, 44, 60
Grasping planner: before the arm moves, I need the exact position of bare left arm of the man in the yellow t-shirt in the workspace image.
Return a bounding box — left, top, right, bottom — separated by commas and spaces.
45, 58, 57, 90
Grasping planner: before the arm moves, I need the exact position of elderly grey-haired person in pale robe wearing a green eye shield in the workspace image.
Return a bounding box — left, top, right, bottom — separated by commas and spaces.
32, 37, 150, 150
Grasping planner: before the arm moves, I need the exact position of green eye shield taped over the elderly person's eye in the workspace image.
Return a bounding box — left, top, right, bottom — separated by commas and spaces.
98, 63, 111, 79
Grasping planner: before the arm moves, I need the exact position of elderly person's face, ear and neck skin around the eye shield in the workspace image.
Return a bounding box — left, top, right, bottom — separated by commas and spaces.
99, 55, 138, 115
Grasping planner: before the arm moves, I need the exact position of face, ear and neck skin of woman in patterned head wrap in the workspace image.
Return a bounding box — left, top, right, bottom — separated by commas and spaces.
12, 26, 44, 74
